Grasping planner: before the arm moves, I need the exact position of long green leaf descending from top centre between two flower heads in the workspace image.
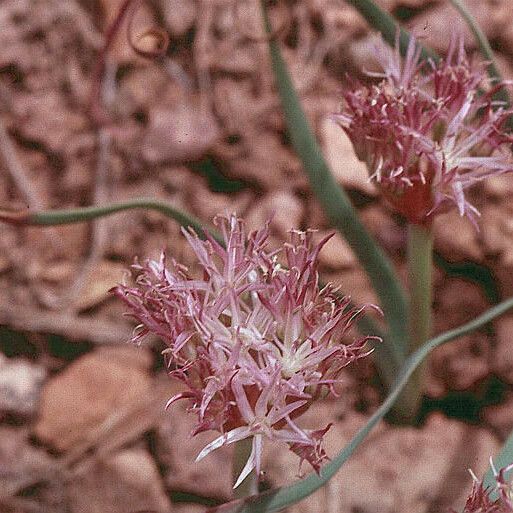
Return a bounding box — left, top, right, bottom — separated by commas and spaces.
262, 1, 407, 372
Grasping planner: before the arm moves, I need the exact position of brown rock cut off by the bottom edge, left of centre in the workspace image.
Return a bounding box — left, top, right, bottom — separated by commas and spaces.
68, 449, 171, 513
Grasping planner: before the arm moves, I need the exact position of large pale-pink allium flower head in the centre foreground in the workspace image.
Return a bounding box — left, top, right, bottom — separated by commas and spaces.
114, 216, 371, 486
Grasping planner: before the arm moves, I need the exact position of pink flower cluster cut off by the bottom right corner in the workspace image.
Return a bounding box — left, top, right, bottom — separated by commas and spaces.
451, 464, 513, 513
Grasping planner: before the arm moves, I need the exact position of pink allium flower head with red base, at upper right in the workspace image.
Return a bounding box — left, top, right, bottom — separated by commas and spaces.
334, 32, 513, 224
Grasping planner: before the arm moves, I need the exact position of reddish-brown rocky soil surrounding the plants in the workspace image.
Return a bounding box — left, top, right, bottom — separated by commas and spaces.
0, 0, 513, 513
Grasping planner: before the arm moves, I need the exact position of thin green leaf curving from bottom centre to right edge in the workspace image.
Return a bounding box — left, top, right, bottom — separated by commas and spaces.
207, 298, 513, 513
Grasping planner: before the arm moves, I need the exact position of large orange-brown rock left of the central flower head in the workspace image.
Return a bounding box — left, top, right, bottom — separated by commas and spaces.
34, 346, 151, 451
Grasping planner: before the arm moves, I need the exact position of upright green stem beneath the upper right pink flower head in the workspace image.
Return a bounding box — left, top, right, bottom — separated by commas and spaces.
393, 224, 433, 423
